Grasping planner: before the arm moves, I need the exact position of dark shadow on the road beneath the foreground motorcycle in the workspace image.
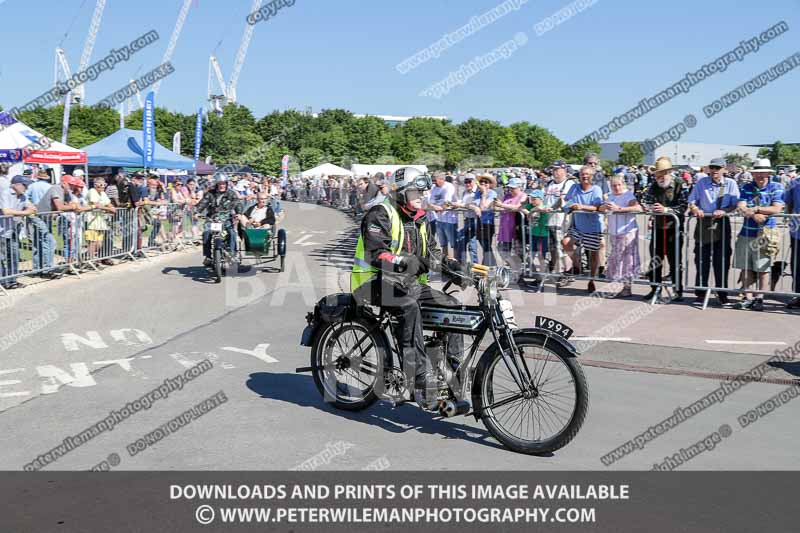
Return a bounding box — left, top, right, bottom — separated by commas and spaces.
247, 372, 512, 453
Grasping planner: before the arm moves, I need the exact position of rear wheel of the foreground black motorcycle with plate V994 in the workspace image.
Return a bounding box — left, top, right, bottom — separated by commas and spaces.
311, 319, 388, 411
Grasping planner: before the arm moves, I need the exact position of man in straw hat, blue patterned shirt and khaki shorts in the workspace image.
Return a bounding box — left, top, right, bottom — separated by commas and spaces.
733, 163, 784, 311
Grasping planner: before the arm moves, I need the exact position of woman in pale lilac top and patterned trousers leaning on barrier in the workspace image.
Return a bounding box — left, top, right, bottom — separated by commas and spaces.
600, 174, 642, 298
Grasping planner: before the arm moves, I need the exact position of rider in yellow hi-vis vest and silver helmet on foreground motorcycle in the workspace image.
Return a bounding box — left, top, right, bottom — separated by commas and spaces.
350, 167, 463, 405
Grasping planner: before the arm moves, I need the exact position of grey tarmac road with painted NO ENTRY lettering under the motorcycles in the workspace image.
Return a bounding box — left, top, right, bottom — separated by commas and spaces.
0, 204, 800, 470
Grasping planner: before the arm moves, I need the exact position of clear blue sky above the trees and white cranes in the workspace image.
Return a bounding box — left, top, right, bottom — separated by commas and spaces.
0, 0, 800, 144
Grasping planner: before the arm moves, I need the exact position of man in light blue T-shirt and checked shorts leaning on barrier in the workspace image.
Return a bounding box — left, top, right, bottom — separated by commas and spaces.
563, 165, 603, 292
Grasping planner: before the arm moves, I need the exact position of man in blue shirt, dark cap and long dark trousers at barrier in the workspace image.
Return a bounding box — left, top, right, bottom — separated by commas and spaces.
689, 158, 739, 305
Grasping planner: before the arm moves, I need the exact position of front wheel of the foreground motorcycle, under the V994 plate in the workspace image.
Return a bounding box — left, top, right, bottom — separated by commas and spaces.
473, 333, 589, 455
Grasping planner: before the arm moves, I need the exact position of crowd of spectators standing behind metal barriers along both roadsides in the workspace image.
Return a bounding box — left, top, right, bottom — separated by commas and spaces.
0, 153, 800, 310
